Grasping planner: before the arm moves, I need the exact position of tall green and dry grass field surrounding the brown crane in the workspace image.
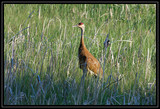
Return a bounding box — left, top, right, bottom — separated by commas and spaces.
4, 4, 156, 105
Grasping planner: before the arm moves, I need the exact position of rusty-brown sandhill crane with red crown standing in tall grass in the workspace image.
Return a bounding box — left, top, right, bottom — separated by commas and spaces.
73, 23, 103, 77
